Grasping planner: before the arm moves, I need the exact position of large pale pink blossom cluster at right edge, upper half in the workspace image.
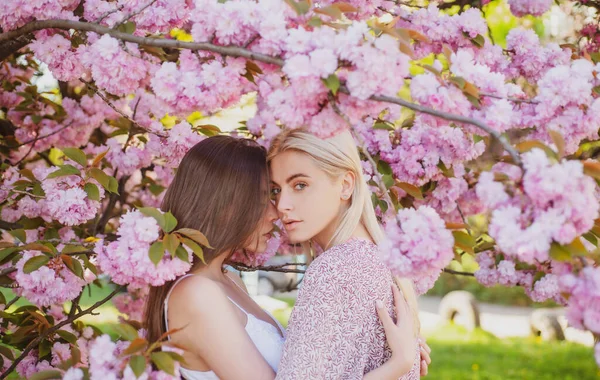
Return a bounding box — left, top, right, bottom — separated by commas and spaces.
524, 59, 600, 154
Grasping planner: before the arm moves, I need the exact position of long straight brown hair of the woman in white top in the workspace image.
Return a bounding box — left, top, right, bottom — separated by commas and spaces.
144, 136, 269, 342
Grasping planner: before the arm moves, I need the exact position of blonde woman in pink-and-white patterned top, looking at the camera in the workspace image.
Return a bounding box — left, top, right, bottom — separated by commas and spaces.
267, 130, 429, 379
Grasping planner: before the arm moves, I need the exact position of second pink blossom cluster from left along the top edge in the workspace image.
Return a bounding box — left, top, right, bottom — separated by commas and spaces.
83, 0, 193, 35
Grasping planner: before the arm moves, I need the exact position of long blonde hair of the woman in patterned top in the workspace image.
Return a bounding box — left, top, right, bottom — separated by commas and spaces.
267, 129, 420, 332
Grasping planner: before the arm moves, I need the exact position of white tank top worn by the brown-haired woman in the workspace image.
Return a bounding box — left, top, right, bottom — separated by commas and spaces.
164, 274, 285, 380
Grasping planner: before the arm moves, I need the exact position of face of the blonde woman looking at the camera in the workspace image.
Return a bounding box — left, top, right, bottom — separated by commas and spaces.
270, 150, 345, 247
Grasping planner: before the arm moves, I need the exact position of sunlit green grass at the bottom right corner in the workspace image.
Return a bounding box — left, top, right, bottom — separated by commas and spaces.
427, 325, 600, 380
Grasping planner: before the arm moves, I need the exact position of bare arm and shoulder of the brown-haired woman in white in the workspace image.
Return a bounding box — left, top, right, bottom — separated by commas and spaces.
169, 276, 275, 380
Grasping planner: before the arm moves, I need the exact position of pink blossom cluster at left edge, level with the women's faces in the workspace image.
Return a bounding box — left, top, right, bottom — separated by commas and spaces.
1, 166, 105, 226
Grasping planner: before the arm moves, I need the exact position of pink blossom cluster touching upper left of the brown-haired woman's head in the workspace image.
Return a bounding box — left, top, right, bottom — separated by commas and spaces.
144, 121, 204, 168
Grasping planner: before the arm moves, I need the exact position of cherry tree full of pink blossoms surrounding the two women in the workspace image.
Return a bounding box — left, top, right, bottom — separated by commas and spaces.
0, 0, 600, 379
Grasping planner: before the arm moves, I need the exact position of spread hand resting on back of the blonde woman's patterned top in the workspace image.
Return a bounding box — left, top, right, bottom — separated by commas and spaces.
376, 285, 417, 377
